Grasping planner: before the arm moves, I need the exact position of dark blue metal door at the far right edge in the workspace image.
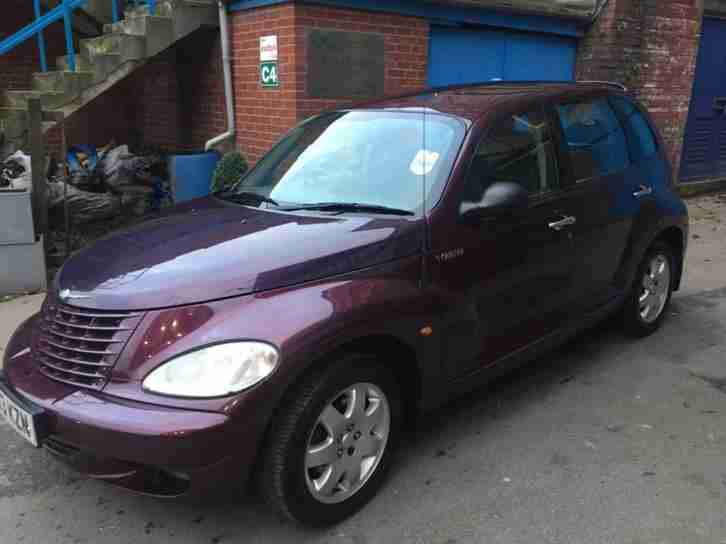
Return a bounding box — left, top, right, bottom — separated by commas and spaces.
681, 18, 726, 181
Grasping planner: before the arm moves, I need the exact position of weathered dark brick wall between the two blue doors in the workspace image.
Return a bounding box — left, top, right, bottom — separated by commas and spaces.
577, 0, 703, 172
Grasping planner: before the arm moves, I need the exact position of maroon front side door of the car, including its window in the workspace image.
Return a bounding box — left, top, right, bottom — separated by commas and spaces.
430, 105, 574, 377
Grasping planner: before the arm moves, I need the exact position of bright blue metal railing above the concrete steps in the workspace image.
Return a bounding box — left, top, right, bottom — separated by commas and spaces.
0, 0, 157, 76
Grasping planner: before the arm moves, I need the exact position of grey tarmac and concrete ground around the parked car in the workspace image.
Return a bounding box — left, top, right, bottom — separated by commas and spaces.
0, 196, 726, 544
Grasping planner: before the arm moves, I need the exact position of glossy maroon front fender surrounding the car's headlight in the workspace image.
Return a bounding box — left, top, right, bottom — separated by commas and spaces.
104, 257, 435, 420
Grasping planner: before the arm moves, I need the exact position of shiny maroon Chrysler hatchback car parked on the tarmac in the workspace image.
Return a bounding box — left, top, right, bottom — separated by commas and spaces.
0, 83, 688, 525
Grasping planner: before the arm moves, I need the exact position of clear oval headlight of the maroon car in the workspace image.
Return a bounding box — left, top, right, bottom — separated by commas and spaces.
144, 342, 280, 398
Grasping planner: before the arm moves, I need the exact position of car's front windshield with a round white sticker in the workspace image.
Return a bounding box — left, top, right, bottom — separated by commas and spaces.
218, 109, 465, 215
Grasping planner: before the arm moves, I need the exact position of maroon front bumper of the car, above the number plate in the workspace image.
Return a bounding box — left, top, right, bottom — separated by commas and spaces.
0, 314, 259, 496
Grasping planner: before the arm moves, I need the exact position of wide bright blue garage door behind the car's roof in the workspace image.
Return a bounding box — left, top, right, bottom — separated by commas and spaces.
429, 27, 577, 86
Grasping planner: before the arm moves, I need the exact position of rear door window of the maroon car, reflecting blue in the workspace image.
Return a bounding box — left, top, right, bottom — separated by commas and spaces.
557, 98, 628, 181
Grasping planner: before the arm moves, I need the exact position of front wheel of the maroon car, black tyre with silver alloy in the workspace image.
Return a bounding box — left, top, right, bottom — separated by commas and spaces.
260, 355, 402, 527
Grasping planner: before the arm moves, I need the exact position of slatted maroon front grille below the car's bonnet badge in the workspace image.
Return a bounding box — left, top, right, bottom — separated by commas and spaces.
33, 302, 143, 389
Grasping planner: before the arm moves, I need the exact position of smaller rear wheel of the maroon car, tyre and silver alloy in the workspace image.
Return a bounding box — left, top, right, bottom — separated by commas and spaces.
623, 241, 676, 338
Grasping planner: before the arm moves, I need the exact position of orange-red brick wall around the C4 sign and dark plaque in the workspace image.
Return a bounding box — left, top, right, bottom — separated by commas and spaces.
232, 4, 429, 162
